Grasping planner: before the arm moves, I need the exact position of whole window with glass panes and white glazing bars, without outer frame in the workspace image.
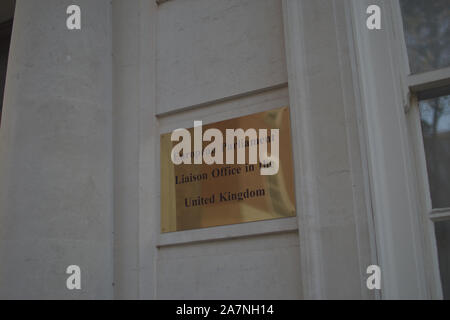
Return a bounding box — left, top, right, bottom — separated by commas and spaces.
400, 0, 450, 299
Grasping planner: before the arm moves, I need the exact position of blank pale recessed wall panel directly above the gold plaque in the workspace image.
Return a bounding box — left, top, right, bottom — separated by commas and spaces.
157, 0, 287, 114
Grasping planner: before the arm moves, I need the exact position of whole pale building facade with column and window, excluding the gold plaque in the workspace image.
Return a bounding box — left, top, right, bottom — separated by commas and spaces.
0, 0, 450, 299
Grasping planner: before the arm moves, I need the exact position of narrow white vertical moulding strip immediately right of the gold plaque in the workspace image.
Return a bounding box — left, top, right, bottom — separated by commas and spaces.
283, 0, 325, 299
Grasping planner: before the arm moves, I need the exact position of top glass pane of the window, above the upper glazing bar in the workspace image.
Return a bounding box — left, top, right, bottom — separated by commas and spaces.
400, 0, 450, 73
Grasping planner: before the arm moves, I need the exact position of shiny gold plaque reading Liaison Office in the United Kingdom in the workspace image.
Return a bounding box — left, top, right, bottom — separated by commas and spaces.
161, 107, 296, 233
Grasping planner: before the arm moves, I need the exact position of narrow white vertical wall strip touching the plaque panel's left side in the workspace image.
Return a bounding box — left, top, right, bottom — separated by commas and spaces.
138, 0, 160, 299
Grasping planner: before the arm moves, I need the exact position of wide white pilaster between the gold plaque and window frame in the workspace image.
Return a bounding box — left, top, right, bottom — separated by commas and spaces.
283, 0, 376, 299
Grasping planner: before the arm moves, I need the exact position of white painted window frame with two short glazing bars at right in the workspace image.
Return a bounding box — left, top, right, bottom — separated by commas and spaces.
349, 0, 449, 299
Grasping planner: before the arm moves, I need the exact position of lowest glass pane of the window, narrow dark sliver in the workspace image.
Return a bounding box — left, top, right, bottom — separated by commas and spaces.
434, 221, 450, 300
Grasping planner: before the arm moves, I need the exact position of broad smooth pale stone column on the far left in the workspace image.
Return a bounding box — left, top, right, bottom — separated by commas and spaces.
0, 0, 113, 299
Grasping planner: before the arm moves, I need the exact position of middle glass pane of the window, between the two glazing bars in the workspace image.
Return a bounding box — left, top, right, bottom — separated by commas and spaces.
419, 95, 450, 208
